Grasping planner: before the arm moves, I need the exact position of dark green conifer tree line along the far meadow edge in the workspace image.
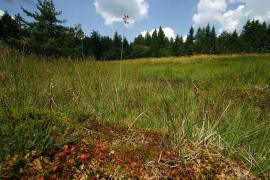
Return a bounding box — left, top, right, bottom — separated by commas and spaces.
0, 0, 270, 60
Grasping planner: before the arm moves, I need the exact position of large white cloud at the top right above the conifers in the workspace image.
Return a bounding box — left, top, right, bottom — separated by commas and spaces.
193, 0, 270, 33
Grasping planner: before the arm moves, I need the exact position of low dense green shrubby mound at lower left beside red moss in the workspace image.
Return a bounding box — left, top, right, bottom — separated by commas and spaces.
0, 109, 75, 159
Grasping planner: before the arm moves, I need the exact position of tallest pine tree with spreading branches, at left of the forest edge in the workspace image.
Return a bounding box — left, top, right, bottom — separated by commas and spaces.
22, 0, 76, 55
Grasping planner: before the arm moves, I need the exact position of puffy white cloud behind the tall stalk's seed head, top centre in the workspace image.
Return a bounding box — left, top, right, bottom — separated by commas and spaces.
94, 0, 149, 26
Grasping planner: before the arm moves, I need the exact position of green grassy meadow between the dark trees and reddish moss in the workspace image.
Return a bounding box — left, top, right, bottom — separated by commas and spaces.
0, 45, 270, 175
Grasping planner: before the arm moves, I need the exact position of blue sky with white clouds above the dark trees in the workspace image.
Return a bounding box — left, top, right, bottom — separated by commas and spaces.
0, 0, 270, 40
